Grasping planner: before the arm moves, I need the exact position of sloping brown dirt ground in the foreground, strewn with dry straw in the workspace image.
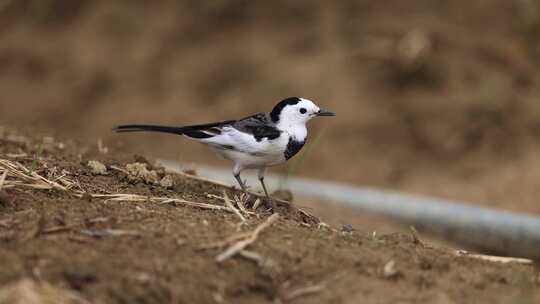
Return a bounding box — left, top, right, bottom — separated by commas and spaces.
0, 128, 540, 304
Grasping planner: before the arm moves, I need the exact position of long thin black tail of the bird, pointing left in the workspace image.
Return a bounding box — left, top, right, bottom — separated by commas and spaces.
113, 120, 235, 139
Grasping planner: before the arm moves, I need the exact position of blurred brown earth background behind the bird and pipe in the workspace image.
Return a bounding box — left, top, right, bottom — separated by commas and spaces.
0, 0, 540, 218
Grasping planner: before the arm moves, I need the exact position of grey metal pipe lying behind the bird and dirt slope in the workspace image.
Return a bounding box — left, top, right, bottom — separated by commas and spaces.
159, 160, 540, 260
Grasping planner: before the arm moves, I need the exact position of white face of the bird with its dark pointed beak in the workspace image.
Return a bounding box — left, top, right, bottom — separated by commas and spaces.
279, 98, 334, 125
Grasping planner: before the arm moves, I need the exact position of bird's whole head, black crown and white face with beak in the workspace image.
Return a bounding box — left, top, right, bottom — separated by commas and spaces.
270, 97, 336, 125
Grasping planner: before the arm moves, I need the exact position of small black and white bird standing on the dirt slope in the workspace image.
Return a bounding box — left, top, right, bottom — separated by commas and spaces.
113, 97, 335, 211
